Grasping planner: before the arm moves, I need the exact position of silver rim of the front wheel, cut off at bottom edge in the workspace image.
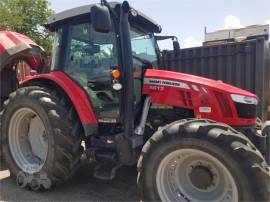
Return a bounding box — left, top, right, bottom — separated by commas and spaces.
156, 149, 238, 201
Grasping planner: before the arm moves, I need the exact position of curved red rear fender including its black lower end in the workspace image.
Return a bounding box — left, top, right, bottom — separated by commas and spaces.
21, 71, 97, 136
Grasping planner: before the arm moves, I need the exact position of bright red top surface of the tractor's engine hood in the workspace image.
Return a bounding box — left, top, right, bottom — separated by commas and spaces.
145, 69, 257, 98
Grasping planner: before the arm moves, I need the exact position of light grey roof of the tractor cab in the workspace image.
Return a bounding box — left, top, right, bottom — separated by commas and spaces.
46, 2, 161, 33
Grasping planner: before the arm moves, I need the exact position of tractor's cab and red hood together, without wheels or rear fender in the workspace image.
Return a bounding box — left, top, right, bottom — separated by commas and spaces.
47, 1, 258, 147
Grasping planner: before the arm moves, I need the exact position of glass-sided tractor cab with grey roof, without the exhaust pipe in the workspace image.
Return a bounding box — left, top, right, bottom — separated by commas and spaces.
47, 3, 161, 123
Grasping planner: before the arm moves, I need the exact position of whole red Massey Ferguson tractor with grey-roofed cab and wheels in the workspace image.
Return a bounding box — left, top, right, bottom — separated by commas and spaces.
1, 1, 270, 201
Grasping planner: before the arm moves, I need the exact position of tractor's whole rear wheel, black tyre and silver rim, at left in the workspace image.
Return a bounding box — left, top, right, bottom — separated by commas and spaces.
1, 86, 83, 190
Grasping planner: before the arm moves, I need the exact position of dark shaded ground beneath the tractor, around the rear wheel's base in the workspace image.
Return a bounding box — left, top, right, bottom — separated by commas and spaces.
0, 163, 139, 201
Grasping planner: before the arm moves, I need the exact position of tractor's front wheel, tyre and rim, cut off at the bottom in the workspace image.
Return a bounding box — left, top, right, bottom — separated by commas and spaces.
137, 120, 270, 201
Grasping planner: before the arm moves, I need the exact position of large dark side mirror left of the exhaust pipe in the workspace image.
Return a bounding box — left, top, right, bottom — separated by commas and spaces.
91, 4, 112, 33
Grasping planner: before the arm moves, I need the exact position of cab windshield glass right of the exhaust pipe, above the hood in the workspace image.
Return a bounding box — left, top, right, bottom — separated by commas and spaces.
130, 27, 158, 68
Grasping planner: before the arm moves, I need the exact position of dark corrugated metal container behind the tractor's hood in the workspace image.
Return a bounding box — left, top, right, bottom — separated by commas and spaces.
161, 37, 270, 121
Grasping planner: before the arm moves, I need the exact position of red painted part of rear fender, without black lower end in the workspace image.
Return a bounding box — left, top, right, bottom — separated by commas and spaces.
24, 71, 97, 124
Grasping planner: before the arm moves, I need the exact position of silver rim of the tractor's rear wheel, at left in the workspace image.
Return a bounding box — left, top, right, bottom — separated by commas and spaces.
8, 108, 48, 173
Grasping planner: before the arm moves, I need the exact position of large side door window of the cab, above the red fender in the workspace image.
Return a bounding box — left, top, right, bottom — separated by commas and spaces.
64, 23, 119, 118
